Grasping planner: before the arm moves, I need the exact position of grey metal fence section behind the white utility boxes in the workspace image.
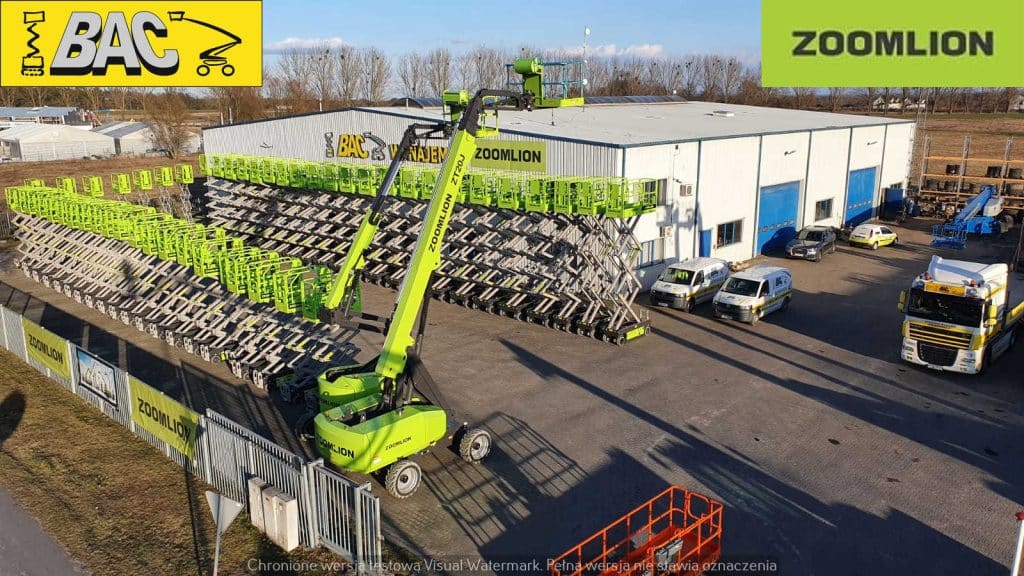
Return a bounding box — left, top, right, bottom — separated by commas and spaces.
198, 409, 317, 548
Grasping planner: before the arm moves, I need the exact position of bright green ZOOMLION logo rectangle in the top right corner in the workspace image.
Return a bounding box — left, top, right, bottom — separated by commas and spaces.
761, 0, 1024, 87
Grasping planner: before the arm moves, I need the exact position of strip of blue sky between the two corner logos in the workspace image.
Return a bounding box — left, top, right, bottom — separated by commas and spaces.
263, 0, 761, 61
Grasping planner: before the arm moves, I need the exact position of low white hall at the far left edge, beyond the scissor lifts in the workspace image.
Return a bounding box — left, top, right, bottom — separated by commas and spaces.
0, 123, 114, 162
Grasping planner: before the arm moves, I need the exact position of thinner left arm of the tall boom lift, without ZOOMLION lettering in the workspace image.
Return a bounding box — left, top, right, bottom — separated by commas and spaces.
323, 124, 452, 324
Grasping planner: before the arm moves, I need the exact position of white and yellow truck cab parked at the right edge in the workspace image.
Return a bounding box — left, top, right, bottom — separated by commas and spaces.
899, 256, 1024, 374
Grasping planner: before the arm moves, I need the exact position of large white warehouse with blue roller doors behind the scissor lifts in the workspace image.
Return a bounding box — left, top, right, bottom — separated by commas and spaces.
204, 98, 914, 287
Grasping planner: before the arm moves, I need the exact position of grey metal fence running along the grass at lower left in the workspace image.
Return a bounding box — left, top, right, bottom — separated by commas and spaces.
0, 306, 382, 575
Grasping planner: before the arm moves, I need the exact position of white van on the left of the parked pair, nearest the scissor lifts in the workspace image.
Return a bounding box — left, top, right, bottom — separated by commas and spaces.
650, 258, 729, 312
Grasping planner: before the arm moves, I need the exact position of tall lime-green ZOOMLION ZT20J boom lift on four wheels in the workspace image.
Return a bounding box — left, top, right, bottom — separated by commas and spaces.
313, 61, 581, 498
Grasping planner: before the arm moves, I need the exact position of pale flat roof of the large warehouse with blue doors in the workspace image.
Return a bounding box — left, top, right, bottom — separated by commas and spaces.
358, 101, 912, 147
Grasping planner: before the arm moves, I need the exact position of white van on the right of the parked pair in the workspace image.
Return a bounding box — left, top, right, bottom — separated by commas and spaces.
715, 265, 793, 324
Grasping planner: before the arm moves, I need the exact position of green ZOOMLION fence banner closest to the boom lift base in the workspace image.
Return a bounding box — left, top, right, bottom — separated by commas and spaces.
128, 376, 199, 459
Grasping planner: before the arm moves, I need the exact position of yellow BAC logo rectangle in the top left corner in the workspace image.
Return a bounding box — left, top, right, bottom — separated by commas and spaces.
0, 0, 263, 86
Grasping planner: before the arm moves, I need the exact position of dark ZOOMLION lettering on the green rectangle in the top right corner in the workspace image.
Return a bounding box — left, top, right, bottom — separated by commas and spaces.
793, 30, 995, 56
